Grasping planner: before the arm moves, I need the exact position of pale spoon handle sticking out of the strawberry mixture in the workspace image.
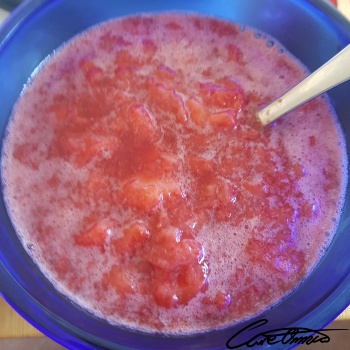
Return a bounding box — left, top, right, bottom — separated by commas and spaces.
258, 45, 350, 125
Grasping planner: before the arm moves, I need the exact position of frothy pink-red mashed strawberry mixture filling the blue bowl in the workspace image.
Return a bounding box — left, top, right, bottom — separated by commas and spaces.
2, 14, 347, 334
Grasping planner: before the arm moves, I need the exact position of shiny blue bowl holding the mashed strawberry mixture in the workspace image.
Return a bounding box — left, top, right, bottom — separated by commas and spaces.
0, 0, 350, 349
